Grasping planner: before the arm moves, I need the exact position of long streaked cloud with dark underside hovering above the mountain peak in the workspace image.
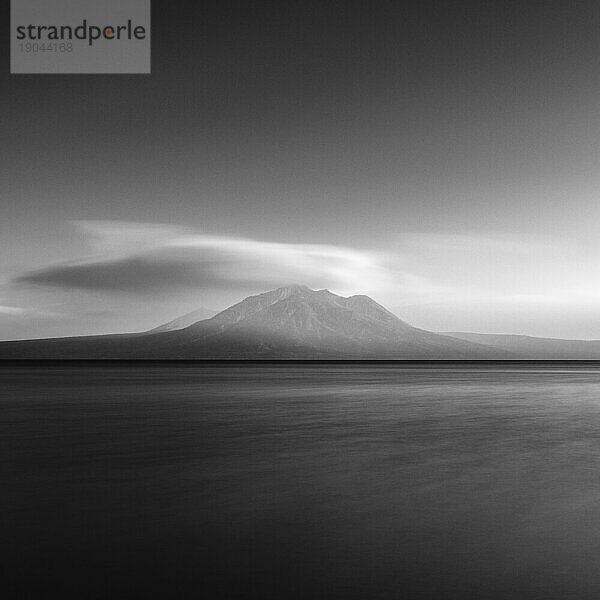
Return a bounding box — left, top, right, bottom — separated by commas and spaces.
15, 221, 389, 293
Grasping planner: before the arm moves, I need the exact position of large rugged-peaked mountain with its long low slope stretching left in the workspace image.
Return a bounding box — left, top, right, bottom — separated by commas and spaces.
0, 286, 511, 360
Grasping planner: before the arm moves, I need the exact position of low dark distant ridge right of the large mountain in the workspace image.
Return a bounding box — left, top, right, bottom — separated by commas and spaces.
443, 332, 600, 360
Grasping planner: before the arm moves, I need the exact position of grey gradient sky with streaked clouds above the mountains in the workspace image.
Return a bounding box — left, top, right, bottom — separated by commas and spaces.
0, 0, 600, 339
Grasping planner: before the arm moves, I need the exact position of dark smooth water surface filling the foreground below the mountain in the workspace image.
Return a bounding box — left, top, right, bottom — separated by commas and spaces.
0, 363, 600, 600
